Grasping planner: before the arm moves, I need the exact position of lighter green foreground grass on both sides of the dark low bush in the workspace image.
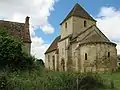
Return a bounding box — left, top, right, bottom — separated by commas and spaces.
0, 68, 120, 90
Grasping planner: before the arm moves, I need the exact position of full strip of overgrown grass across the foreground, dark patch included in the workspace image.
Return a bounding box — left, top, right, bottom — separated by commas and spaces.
0, 67, 120, 90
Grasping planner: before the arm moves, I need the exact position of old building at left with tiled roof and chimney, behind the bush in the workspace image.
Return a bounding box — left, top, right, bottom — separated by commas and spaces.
0, 16, 31, 55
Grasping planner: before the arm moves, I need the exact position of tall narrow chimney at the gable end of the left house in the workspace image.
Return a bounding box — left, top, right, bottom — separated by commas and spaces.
24, 16, 31, 43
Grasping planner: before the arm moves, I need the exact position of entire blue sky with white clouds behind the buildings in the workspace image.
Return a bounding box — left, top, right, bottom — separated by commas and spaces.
0, 0, 120, 60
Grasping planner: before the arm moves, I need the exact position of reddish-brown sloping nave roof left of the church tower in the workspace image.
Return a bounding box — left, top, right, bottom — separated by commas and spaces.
45, 36, 61, 54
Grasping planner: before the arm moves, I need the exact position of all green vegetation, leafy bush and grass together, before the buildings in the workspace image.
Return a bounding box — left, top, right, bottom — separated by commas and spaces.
0, 29, 120, 90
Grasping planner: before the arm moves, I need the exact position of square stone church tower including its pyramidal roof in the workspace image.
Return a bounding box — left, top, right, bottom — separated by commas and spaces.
60, 3, 96, 38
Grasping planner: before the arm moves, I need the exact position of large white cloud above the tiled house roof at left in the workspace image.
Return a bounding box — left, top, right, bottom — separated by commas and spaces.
0, 0, 57, 34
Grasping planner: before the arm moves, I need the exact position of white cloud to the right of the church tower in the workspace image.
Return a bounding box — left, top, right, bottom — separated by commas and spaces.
96, 7, 120, 54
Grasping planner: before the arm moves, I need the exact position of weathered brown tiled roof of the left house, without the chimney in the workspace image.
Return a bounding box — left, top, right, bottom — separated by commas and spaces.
0, 20, 31, 43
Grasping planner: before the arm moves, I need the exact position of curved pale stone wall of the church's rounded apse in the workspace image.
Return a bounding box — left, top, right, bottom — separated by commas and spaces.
76, 43, 117, 72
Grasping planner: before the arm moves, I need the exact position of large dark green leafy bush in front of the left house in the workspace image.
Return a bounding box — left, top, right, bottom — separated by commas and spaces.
0, 29, 33, 70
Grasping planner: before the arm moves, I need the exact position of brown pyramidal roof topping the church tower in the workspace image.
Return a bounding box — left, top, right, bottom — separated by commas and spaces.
60, 3, 96, 25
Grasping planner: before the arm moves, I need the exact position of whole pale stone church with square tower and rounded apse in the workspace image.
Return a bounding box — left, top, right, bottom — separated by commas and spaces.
45, 3, 117, 72
